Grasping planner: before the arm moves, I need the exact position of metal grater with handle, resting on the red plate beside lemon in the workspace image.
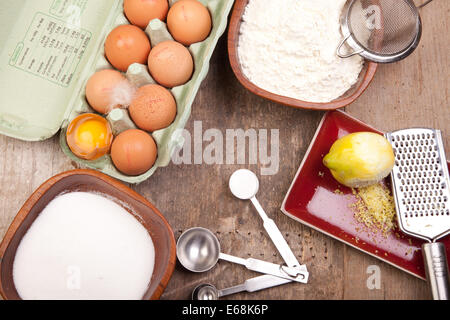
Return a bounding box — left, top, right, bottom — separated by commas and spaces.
385, 128, 450, 300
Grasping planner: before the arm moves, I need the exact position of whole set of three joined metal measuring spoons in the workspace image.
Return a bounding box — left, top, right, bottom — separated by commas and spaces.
177, 169, 309, 300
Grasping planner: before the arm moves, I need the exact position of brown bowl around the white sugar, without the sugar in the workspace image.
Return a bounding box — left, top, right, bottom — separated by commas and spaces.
0, 170, 176, 300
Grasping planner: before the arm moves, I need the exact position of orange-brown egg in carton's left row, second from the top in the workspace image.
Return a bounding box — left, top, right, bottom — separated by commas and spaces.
105, 25, 151, 72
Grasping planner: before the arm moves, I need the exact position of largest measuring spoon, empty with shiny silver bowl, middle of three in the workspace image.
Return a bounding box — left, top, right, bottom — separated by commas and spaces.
177, 228, 309, 283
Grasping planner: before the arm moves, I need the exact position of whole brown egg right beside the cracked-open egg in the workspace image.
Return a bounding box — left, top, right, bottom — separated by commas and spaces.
111, 129, 158, 176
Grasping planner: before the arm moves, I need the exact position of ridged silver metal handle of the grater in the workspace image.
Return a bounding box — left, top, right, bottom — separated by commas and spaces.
422, 242, 450, 300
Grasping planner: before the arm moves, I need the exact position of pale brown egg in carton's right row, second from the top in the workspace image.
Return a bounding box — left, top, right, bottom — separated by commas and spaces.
148, 41, 194, 88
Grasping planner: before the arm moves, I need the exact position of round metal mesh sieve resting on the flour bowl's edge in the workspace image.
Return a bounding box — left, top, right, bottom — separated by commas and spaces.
337, 0, 432, 63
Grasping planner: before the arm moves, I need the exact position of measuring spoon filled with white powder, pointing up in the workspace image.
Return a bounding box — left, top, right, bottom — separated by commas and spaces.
229, 169, 307, 271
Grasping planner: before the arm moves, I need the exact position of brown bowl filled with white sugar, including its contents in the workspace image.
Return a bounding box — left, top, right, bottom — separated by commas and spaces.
0, 170, 176, 300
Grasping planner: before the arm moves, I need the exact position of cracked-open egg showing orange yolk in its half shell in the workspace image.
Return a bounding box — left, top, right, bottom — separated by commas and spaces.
67, 114, 113, 160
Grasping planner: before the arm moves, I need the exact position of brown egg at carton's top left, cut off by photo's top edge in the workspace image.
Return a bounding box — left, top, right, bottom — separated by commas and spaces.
123, 0, 169, 29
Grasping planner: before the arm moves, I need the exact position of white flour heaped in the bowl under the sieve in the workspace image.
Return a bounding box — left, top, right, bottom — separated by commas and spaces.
238, 0, 363, 102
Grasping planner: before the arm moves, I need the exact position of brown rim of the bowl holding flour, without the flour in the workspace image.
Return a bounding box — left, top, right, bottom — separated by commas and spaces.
228, 0, 378, 110
